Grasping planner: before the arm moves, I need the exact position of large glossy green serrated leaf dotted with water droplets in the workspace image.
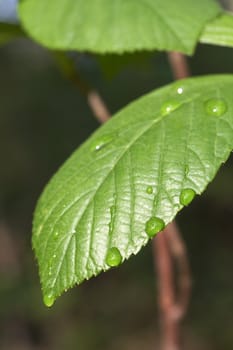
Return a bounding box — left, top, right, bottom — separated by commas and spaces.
33, 75, 233, 306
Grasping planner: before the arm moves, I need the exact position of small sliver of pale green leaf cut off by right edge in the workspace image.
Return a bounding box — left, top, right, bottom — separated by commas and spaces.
200, 12, 233, 47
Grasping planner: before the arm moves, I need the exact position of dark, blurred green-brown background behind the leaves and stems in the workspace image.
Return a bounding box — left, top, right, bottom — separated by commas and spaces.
0, 2, 233, 350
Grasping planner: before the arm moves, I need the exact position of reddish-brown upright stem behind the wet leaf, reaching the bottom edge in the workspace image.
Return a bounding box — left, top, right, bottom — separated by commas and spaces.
153, 52, 191, 350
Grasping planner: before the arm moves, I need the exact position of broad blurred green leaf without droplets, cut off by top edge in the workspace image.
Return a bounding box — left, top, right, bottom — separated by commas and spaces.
19, 0, 221, 54
